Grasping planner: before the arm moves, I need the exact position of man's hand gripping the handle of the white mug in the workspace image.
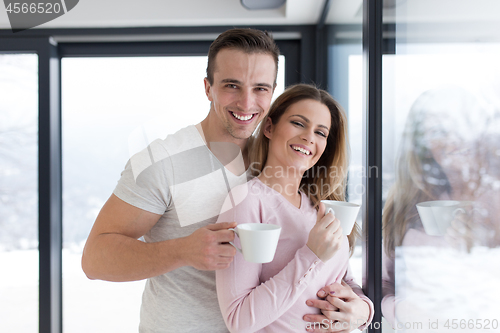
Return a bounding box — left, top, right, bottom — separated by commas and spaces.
181, 222, 237, 270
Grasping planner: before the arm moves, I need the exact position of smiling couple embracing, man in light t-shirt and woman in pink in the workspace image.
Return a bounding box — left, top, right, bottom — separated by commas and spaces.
82, 29, 373, 332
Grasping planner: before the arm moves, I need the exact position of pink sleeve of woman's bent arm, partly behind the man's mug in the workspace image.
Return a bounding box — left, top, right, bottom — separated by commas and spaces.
216, 185, 324, 332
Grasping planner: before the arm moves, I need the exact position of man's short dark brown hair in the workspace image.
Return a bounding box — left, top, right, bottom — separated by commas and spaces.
207, 29, 280, 85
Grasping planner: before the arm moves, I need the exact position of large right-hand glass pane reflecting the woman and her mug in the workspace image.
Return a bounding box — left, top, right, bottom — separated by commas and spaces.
382, 1, 500, 332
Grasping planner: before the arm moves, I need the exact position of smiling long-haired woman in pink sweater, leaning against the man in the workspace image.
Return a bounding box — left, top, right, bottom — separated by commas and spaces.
216, 84, 373, 332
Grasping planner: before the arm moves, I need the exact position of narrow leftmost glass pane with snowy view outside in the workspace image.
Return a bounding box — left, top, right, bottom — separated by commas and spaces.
0, 54, 38, 332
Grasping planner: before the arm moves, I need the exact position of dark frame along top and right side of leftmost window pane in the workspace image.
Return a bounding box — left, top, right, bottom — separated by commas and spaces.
0, 37, 62, 332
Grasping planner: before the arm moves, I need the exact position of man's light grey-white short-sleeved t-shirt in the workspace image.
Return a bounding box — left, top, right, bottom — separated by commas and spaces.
113, 126, 248, 333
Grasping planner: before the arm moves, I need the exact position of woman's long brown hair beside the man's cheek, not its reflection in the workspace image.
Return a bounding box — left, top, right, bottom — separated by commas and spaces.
249, 84, 360, 255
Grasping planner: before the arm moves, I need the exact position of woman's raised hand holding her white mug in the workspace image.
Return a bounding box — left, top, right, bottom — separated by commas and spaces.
307, 202, 344, 262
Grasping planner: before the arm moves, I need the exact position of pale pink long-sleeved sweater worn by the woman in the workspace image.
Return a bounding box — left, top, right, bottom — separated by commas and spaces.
216, 178, 373, 332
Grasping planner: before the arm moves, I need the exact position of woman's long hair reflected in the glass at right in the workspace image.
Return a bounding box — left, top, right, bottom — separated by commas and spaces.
382, 86, 477, 257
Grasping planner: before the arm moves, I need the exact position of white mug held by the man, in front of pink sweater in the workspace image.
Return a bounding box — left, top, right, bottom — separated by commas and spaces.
229, 223, 281, 264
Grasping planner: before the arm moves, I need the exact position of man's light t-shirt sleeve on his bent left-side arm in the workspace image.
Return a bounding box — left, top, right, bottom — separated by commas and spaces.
113, 143, 171, 214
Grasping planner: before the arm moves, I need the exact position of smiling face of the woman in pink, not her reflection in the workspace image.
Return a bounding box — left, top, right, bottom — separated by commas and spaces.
264, 99, 331, 175
